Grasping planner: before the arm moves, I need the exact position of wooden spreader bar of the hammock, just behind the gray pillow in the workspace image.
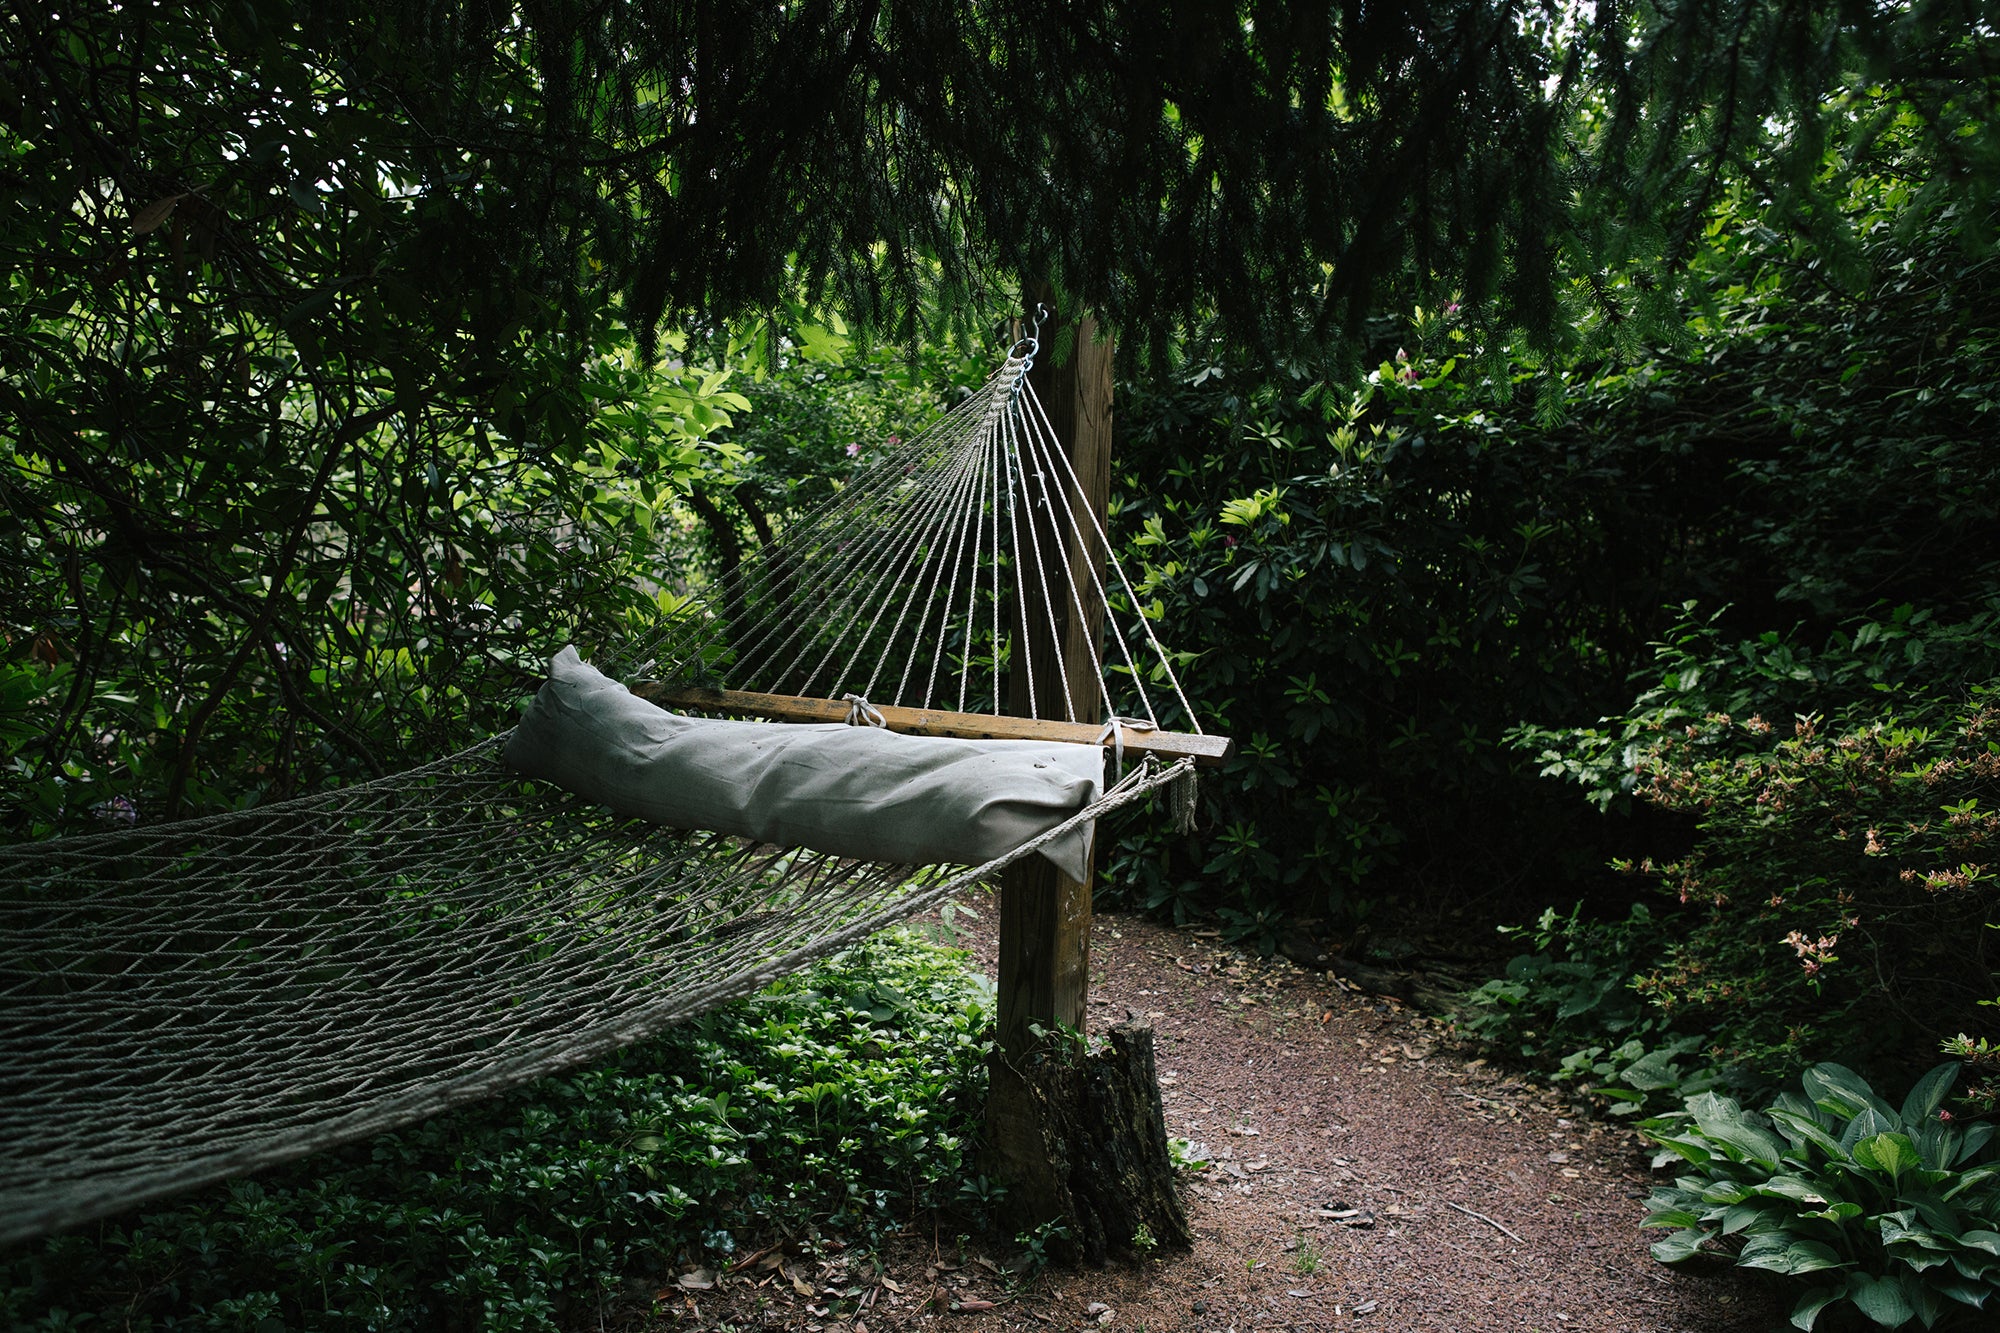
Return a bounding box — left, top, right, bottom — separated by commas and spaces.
632, 681, 1236, 769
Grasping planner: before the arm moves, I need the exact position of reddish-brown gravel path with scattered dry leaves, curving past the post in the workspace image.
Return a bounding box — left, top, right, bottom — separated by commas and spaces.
652, 903, 1788, 1333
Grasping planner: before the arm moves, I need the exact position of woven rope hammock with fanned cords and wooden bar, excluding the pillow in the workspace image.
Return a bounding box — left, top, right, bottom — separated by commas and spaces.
0, 340, 1228, 1243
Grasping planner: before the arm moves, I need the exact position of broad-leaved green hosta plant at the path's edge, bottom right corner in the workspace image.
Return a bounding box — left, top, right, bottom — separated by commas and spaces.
1642, 1063, 2000, 1329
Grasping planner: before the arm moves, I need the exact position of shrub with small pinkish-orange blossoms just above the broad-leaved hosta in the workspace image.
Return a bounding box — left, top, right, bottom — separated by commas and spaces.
1518, 608, 2000, 1083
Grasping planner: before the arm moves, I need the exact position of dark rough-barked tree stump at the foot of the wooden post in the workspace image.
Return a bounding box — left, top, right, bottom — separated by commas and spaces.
986, 1023, 1194, 1265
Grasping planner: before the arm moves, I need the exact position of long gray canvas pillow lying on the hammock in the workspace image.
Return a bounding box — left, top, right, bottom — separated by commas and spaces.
494, 648, 1104, 879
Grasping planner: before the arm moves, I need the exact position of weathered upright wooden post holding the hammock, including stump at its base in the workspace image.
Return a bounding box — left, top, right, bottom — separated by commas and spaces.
986, 290, 1192, 1263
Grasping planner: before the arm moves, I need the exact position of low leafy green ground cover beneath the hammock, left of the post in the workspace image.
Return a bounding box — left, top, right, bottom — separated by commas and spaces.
0, 931, 992, 1333
